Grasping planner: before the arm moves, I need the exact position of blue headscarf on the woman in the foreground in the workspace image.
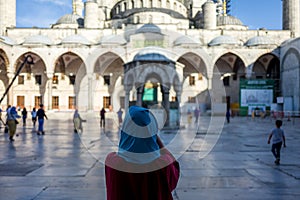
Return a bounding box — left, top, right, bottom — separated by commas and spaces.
118, 106, 160, 164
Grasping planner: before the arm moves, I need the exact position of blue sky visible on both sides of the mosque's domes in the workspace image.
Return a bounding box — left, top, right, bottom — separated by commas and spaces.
17, 0, 282, 29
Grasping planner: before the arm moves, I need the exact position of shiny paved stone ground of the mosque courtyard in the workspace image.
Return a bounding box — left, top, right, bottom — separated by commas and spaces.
0, 113, 300, 200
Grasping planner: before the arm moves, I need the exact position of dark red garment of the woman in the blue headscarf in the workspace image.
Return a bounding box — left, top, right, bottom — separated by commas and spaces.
105, 152, 180, 200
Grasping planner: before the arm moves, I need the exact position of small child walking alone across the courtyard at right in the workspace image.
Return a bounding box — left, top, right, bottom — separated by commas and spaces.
268, 120, 286, 165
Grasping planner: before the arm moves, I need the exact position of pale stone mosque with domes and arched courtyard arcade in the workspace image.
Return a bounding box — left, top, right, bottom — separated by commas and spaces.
0, 0, 300, 122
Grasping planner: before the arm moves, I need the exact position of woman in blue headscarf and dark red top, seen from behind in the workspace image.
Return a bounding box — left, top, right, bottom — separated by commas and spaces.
105, 106, 180, 200
